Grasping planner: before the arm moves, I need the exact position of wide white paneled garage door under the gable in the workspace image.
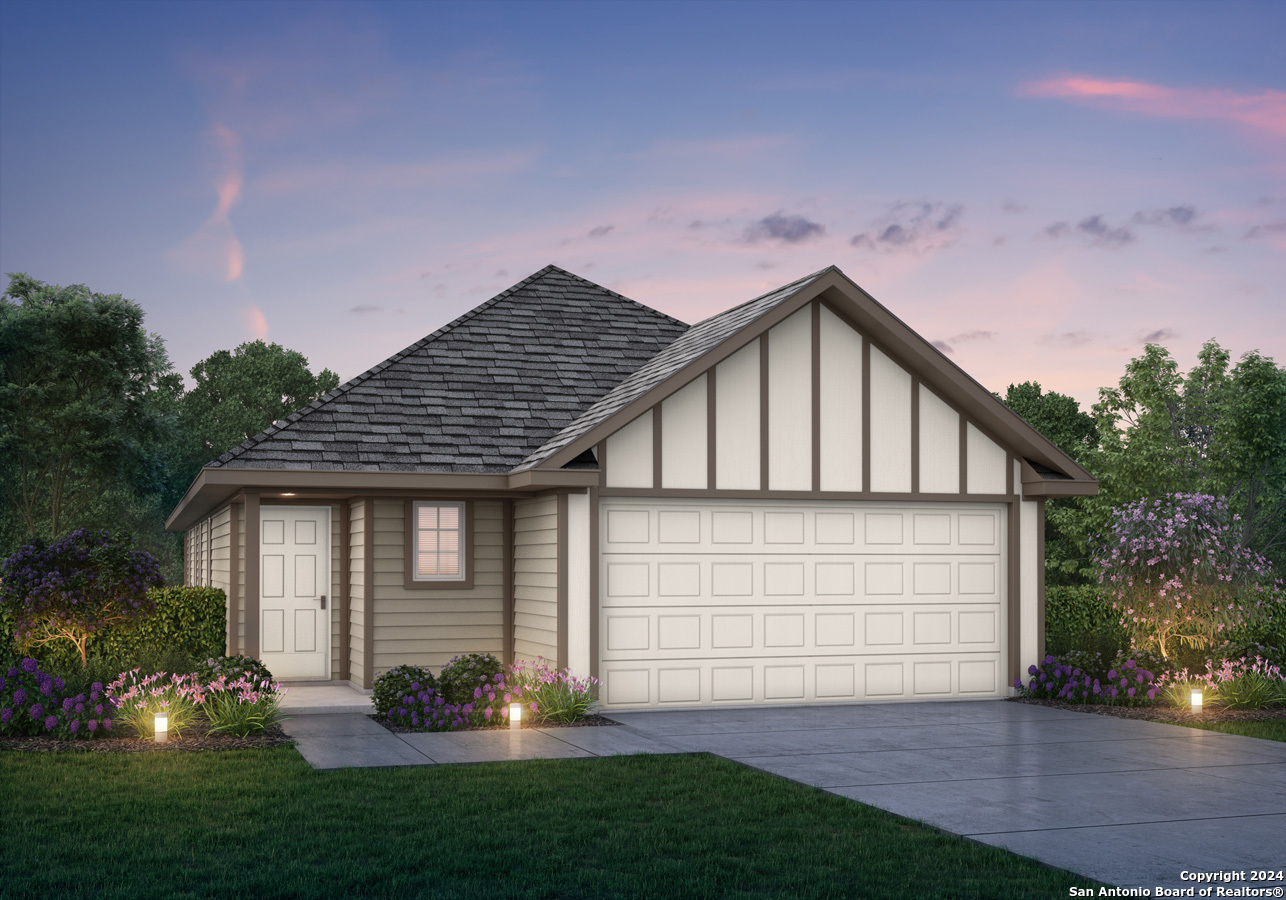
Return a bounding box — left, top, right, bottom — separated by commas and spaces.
598, 499, 1006, 708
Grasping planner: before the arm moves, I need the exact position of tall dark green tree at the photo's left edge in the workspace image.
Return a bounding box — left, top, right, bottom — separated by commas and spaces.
0, 274, 172, 539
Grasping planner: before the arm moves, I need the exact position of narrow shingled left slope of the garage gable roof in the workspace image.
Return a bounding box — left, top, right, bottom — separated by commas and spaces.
514, 266, 833, 472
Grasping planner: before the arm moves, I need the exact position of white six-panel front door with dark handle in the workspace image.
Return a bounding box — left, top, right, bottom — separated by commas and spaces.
258, 507, 333, 678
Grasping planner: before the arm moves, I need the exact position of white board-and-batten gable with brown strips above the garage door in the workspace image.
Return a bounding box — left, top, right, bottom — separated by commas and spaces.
601, 301, 1016, 499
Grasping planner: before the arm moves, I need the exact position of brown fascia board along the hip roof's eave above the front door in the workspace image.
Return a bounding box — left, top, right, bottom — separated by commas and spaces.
165, 467, 598, 531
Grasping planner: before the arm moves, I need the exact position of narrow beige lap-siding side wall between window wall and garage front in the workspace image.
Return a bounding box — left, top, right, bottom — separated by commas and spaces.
513, 494, 558, 661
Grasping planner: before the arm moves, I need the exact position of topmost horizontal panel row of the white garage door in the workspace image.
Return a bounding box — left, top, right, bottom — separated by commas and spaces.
601, 500, 1002, 554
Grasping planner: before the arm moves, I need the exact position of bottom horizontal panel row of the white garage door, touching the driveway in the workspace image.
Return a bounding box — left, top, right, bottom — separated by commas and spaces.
599, 654, 1002, 708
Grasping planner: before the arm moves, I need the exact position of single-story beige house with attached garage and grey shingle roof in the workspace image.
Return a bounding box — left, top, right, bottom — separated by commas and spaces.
167, 266, 1097, 708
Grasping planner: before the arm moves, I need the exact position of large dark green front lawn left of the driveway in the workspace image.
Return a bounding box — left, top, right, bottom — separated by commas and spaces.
0, 748, 1094, 900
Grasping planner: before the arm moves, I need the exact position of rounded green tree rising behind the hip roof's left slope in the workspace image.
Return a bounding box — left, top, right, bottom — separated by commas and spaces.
180, 341, 340, 470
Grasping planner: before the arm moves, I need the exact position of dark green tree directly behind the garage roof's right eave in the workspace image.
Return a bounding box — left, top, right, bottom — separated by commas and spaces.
997, 382, 1098, 585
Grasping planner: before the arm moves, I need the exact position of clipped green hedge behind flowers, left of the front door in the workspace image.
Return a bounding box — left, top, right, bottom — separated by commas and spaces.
0, 586, 226, 671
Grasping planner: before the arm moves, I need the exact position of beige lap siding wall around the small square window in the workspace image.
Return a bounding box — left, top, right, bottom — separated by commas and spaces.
374, 499, 504, 675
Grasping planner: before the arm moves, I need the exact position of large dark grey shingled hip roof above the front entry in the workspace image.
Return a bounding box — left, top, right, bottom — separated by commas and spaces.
210, 266, 688, 472
